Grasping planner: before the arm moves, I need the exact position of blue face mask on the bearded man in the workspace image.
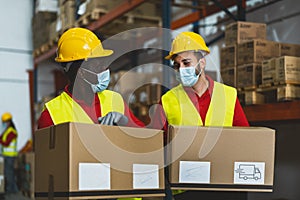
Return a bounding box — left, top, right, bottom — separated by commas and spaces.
176, 66, 202, 87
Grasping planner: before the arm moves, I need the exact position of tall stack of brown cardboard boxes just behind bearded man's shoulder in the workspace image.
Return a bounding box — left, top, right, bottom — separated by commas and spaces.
220, 21, 268, 102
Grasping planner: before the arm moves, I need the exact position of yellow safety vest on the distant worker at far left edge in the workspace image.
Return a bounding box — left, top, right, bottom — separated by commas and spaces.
2, 126, 18, 157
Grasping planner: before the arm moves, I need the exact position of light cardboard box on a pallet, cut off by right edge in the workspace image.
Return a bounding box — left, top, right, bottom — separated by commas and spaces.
275, 56, 300, 84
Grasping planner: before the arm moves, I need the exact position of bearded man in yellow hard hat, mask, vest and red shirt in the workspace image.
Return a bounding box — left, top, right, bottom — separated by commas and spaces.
153, 32, 249, 199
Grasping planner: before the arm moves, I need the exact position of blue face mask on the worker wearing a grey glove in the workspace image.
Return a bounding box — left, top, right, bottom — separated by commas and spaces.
84, 69, 110, 93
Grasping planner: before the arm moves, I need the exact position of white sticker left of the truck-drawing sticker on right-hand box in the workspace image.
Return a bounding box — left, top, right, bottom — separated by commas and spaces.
179, 161, 210, 183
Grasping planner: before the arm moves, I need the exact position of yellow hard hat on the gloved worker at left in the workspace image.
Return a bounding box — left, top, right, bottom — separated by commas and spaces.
55, 28, 113, 62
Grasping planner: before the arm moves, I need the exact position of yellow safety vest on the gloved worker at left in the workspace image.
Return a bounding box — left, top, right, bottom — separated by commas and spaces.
45, 90, 125, 125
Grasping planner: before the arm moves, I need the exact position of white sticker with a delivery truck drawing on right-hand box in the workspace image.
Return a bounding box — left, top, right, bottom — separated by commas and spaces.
234, 162, 265, 185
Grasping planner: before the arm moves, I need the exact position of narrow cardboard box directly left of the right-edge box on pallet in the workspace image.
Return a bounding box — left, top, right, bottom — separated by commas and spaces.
261, 58, 276, 85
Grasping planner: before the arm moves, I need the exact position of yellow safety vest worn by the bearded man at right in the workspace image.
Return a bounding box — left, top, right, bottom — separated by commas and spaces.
162, 82, 237, 126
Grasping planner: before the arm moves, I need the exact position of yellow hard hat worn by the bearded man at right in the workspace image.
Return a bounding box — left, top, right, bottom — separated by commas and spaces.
165, 32, 210, 60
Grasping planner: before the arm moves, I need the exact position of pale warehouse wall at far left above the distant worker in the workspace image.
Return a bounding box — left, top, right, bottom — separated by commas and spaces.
0, 0, 33, 149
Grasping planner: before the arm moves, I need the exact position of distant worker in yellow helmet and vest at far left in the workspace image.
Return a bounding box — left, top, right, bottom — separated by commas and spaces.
0, 112, 18, 196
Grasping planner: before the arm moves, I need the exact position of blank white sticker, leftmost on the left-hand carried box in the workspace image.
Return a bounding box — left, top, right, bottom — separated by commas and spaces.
79, 163, 110, 190
